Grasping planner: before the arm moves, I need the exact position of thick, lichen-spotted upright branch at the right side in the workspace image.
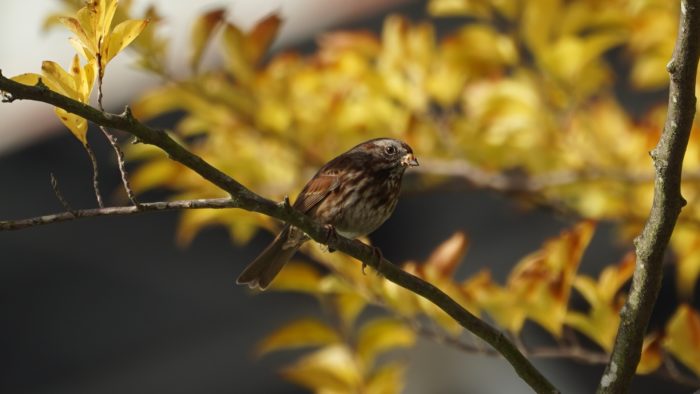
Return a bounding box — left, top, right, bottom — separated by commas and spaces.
598, 0, 700, 394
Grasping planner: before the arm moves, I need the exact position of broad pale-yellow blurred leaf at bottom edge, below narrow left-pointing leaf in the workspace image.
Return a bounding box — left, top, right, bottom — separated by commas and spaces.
281, 344, 362, 394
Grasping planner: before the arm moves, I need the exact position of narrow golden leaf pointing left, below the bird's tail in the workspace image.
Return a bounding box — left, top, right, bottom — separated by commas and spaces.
255, 318, 340, 356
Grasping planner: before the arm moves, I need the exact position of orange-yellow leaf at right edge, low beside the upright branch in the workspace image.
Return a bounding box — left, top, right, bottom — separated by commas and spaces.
663, 304, 700, 375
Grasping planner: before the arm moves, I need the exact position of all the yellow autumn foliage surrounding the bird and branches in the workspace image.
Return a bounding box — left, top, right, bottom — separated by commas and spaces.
8, 0, 700, 393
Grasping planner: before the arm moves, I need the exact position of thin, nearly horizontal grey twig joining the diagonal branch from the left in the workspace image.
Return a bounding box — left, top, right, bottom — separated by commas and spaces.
0, 194, 235, 231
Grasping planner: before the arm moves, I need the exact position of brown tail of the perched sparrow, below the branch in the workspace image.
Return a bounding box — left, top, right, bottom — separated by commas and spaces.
236, 226, 301, 290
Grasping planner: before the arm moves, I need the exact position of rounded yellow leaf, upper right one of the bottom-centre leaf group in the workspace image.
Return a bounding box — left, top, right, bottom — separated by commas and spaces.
357, 317, 416, 368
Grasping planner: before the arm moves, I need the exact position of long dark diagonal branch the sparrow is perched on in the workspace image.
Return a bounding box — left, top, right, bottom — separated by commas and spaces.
0, 69, 558, 393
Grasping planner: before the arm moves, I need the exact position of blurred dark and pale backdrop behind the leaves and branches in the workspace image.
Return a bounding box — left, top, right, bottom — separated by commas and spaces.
0, 0, 688, 394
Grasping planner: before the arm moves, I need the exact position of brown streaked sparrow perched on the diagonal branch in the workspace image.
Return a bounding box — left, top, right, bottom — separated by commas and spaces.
236, 138, 418, 289
